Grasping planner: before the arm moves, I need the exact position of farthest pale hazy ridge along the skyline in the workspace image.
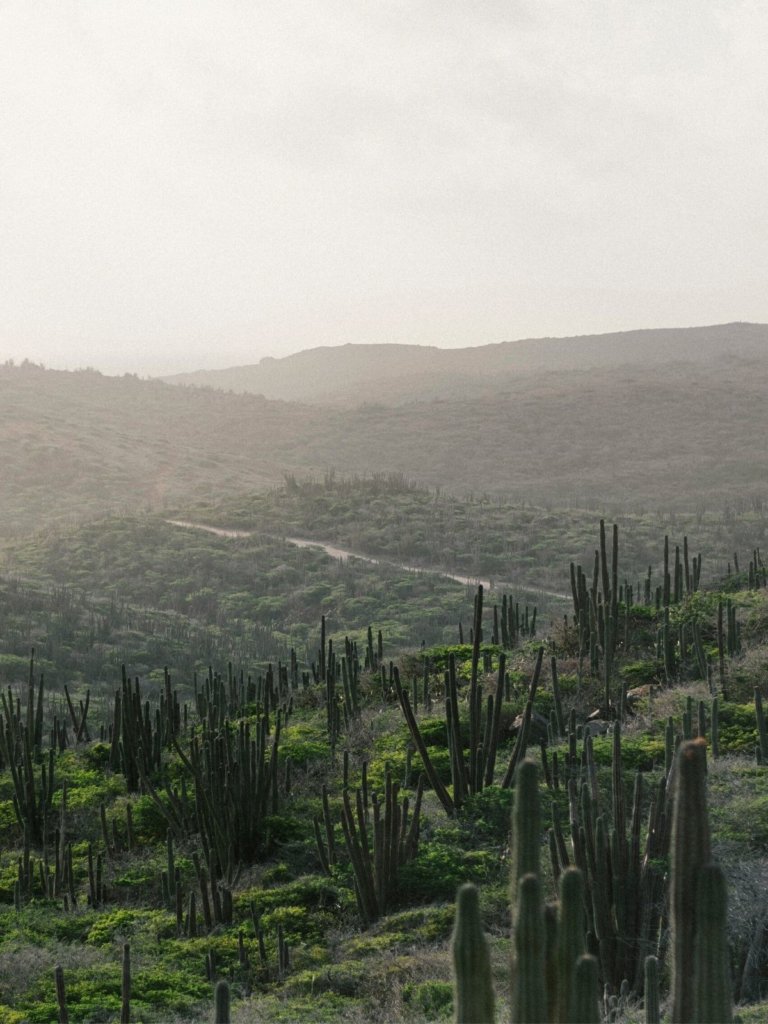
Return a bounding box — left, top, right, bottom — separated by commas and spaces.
164, 324, 768, 406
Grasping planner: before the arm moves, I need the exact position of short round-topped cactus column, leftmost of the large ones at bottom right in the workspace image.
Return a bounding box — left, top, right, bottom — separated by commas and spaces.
451, 885, 494, 1024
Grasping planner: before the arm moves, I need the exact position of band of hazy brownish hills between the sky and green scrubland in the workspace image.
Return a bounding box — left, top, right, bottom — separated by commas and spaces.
0, 325, 768, 536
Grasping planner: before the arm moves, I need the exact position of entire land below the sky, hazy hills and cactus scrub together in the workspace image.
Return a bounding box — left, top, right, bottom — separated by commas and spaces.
0, 325, 768, 1024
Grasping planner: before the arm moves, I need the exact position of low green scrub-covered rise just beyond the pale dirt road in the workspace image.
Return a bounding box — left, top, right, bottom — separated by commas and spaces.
189, 474, 768, 598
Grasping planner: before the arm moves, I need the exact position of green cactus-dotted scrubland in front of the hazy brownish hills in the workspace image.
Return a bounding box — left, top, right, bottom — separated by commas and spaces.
0, 478, 768, 1024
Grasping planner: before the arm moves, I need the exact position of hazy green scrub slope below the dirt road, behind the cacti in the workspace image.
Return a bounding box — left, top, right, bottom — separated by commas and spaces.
0, 515, 479, 684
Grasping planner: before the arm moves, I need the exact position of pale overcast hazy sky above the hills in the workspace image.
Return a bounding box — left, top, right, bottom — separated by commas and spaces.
0, 0, 768, 374
